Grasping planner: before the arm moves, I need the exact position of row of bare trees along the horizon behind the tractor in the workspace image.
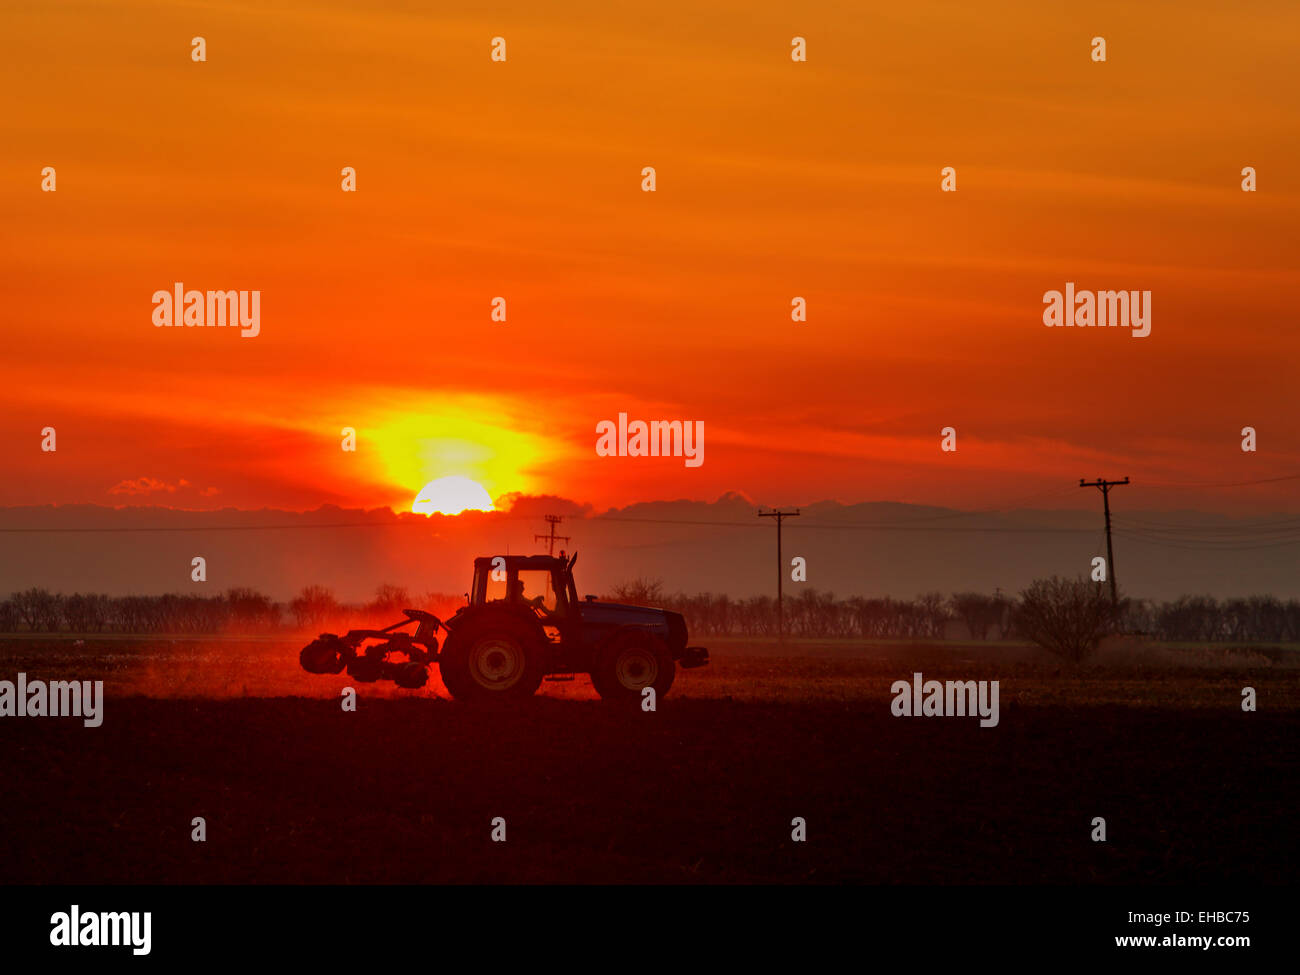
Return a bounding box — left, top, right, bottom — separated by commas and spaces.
10, 579, 1300, 642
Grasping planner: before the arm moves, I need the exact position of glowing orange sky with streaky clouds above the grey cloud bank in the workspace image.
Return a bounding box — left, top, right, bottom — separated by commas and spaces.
0, 0, 1300, 520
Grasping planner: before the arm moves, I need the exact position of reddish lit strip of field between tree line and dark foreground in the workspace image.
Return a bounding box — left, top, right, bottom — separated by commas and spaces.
0, 637, 1300, 707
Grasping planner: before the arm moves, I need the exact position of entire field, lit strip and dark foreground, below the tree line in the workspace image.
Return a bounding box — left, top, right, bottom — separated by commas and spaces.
0, 638, 1300, 884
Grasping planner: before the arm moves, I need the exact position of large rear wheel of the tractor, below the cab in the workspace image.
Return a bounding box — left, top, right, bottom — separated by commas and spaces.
438, 624, 546, 701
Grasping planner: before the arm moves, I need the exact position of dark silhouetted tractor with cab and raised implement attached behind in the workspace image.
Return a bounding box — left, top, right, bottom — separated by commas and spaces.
299, 553, 709, 702
